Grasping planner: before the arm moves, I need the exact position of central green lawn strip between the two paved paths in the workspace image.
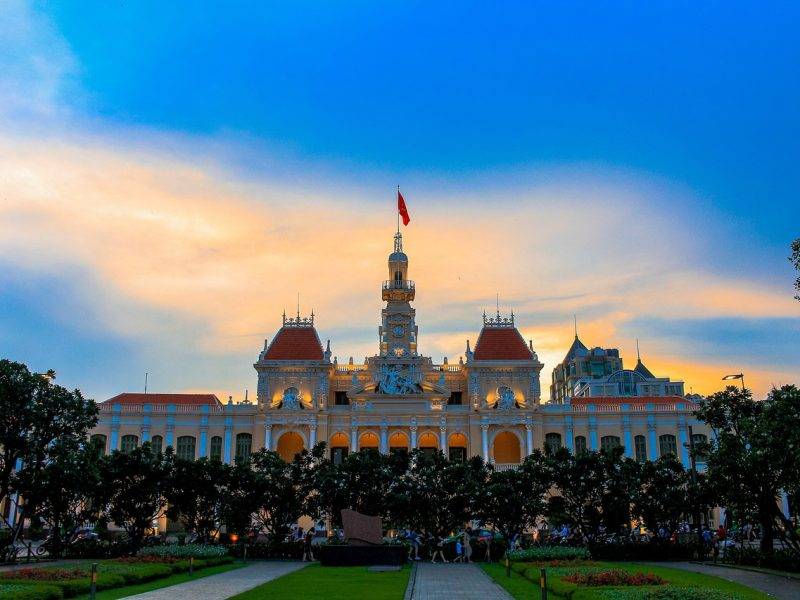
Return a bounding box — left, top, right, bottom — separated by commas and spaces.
228, 564, 411, 600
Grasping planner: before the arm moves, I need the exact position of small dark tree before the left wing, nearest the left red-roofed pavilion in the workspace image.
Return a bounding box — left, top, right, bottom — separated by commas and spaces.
164, 458, 231, 541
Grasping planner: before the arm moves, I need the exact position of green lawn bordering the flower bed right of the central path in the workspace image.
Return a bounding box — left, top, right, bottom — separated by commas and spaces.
480, 562, 769, 600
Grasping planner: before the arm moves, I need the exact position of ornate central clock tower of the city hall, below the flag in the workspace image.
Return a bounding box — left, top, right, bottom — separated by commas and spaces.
378, 231, 417, 358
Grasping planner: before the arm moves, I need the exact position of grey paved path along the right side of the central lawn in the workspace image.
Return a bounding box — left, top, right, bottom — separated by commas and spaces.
411, 561, 511, 600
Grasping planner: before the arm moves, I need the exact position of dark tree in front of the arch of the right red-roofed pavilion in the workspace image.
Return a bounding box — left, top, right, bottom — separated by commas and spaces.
475, 450, 553, 543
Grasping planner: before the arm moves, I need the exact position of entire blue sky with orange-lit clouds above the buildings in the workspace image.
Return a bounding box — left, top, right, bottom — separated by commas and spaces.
0, 0, 800, 400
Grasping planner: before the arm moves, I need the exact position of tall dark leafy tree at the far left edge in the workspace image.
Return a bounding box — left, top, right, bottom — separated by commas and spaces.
0, 359, 97, 540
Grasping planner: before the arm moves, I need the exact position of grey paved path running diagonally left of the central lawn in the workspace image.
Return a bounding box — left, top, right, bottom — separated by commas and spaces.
123, 562, 308, 600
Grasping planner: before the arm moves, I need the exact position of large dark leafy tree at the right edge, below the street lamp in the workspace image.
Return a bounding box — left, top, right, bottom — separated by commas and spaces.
696, 385, 800, 553
